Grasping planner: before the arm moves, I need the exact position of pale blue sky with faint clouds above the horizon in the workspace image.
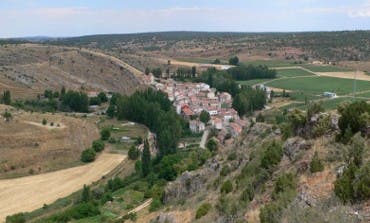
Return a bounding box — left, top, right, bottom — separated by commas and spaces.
0, 0, 370, 38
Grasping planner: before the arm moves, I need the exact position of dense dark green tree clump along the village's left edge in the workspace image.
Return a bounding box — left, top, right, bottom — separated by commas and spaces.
107, 88, 187, 156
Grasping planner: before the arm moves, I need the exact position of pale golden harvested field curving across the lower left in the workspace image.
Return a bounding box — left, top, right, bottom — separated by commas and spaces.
0, 153, 126, 222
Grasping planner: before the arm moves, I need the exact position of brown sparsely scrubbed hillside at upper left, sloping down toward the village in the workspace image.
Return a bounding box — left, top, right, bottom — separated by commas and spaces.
0, 44, 141, 98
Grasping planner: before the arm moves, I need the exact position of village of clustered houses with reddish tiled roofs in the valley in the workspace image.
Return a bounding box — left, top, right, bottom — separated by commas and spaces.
154, 79, 247, 139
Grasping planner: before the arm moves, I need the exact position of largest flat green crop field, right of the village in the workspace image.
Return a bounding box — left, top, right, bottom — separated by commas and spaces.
266, 76, 370, 95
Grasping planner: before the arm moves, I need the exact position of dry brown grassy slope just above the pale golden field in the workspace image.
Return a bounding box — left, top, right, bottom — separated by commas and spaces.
0, 103, 99, 178
